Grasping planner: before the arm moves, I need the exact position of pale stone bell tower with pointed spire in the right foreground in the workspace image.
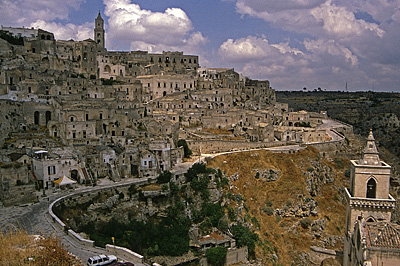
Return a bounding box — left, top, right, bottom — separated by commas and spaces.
343, 130, 396, 266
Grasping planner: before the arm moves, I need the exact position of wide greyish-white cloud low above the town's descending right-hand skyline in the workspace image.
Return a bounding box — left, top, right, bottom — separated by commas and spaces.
219, 36, 366, 90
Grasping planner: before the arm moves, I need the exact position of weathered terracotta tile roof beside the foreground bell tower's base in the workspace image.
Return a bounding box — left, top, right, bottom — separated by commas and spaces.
365, 223, 400, 249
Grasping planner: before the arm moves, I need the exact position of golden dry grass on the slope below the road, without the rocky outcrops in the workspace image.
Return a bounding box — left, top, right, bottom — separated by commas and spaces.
208, 148, 346, 265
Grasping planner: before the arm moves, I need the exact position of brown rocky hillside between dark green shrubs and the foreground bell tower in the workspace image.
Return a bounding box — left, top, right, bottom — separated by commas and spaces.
208, 148, 349, 265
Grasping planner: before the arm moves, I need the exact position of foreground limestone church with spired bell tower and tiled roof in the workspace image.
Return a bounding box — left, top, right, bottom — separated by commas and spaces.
344, 130, 400, 266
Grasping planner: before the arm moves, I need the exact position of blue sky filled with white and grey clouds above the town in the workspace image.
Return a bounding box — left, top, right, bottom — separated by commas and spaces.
0, 0, 400, 92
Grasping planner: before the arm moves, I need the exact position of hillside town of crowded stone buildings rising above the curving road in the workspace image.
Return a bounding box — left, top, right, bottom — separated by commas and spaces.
0, 13, 351, 198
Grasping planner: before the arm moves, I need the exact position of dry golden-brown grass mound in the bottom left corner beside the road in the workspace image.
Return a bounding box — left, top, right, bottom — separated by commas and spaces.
0, 229, 83, 266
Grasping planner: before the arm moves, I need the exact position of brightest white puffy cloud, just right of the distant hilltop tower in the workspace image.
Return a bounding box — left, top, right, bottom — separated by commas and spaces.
104, 0, 207, 52
